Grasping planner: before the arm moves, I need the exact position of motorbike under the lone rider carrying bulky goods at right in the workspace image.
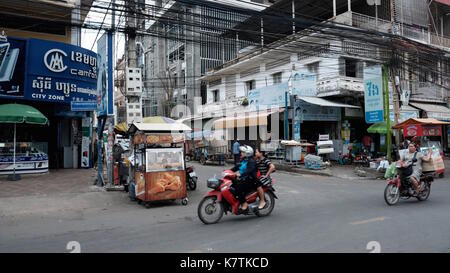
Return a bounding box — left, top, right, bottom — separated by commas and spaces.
384, 159, 434, 206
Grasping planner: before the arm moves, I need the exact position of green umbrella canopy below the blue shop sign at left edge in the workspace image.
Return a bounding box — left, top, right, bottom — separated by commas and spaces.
0, 103, 49, 125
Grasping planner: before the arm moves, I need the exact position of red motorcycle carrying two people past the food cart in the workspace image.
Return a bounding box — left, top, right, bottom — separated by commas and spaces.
197, 170, 278, 225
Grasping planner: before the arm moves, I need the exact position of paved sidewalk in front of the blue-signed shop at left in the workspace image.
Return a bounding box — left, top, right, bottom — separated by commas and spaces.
0, 169, 122, 219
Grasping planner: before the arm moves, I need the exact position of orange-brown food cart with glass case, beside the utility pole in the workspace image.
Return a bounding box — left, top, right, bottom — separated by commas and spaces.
129, 123, 190, 207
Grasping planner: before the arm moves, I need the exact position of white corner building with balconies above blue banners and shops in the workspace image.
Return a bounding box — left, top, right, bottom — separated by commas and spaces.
200, 0, 450, 153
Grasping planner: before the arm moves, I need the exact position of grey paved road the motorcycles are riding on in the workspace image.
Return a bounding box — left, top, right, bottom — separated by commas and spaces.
0, 162, 450, 253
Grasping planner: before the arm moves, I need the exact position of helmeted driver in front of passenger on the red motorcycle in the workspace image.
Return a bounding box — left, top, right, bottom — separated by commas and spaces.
231, 145, 258, 213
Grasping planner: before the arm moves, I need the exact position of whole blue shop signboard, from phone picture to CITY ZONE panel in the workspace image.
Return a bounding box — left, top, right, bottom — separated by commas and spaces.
0, 37, 97, 105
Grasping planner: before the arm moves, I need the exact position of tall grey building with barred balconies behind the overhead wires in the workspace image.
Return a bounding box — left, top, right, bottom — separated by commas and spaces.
138, 0, 276, 116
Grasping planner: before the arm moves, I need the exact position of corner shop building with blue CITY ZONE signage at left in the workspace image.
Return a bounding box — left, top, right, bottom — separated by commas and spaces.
0, 1, 98, 174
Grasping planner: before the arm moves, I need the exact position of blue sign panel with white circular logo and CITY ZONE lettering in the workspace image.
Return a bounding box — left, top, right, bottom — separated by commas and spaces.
25, 39, 97, 104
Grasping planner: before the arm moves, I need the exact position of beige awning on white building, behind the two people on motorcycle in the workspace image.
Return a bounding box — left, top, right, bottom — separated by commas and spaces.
214, 109, 284, 129
